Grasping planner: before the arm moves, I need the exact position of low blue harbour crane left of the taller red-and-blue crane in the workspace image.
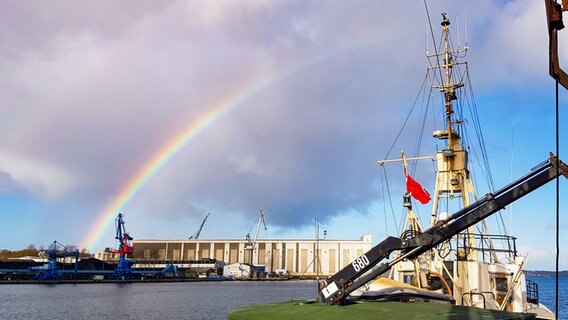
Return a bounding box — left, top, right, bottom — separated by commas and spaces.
35, 241, 79, 280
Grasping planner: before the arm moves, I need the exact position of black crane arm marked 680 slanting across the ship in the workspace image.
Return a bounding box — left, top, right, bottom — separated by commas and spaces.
318, 153, 568, 304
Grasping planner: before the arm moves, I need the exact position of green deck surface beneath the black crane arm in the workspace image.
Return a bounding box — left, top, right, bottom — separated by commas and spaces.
229, 301, 535, 320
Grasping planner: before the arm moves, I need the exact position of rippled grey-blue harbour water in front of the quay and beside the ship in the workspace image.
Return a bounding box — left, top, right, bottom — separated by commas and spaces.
0, 277, 568, 320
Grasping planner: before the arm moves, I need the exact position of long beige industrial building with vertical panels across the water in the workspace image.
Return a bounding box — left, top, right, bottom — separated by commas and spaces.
130, 235, 372, 276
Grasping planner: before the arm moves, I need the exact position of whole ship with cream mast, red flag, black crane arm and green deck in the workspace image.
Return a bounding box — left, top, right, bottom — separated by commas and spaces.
229, 7, 568, 320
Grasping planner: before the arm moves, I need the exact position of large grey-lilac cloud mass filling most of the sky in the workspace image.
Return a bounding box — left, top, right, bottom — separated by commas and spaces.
0, 0, 560, 256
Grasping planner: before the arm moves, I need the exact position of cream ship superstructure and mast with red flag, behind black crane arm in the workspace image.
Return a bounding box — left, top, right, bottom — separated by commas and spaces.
352, 14, 555, 319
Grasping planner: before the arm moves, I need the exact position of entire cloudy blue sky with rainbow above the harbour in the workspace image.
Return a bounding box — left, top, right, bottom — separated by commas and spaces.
0, 0, 568, 270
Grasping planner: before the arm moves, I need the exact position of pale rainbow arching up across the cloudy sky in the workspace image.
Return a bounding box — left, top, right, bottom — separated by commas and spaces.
80, 39, 377, 250
